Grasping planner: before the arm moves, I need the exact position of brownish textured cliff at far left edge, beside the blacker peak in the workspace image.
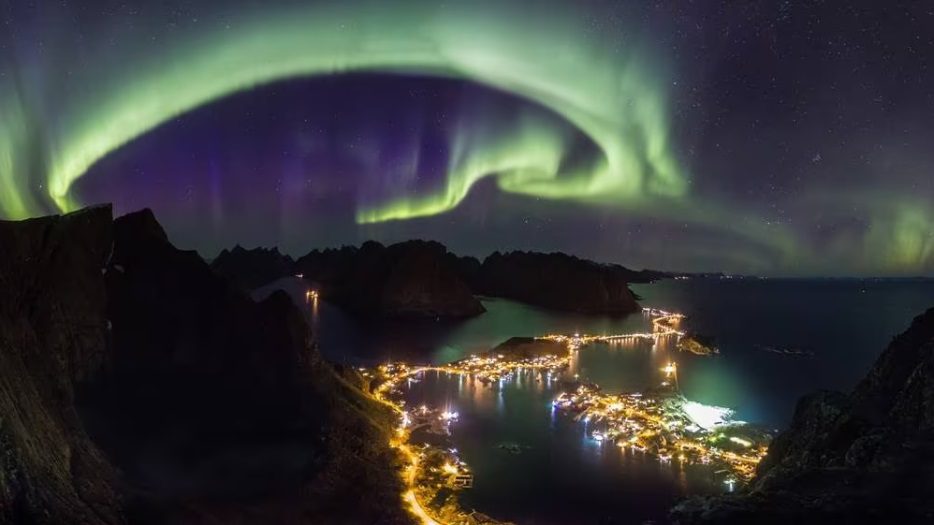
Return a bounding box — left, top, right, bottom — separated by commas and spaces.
0, 207, 123, 524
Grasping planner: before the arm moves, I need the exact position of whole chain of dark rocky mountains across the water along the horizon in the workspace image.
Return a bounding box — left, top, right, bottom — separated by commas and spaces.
212, 240, 665, 319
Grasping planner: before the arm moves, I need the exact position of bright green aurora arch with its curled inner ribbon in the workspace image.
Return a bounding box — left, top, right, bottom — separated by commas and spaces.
0, 3, 686, 223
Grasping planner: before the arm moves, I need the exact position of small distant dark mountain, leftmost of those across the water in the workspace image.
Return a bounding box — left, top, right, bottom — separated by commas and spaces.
211, 244, 295, 290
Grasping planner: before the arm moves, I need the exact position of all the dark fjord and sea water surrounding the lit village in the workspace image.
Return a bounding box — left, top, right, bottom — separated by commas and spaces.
260, 279, 934, 524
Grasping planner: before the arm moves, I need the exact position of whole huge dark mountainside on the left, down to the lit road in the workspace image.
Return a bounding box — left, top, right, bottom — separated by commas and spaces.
0, 208, 406, 524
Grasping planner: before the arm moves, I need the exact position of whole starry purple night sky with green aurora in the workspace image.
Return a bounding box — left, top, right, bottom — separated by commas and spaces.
0, 0, 934, 276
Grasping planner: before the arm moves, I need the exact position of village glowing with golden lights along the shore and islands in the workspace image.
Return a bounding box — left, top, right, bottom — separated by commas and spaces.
361, 308, 771, 525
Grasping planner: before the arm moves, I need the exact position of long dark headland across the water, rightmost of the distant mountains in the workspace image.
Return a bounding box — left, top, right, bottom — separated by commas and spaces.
476, 252, 640, 315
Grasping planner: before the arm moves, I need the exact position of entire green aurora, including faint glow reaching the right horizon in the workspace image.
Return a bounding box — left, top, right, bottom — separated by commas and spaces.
0, 2, 934, 273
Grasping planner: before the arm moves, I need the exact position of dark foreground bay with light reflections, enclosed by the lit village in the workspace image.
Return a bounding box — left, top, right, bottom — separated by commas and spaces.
403, 364, 722, 524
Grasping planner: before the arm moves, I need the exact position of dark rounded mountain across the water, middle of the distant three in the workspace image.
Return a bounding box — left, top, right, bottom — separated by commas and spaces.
295, 241, 484, 318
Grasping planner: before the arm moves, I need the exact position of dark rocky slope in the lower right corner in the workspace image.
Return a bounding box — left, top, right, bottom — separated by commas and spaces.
672, 309, 934, 523
